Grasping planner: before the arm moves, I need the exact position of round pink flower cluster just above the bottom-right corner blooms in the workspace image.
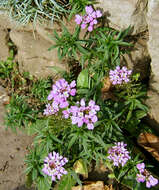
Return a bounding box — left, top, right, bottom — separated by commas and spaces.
107, 142, 130, 166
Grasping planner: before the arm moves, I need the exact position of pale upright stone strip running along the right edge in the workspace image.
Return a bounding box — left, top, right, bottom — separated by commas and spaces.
147, 0, 159, 127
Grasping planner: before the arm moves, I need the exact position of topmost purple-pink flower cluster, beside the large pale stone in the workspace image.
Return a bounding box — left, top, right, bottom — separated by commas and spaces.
75, 6, 102, 32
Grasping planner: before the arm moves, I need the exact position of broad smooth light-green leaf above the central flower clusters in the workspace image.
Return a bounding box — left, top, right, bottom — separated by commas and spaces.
77, 69, 89, 88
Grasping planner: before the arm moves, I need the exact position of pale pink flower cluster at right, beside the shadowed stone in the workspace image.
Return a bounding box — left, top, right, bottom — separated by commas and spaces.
109, 66, 132, 85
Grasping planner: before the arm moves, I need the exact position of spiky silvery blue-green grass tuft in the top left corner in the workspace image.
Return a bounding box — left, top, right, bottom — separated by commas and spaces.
0, 0, 68, 25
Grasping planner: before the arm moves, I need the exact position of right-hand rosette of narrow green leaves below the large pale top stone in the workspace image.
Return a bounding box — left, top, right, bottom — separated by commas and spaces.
83, 27, 131, 72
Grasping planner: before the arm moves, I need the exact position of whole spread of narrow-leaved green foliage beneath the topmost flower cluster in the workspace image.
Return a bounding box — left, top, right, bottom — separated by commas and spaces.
49, 9, 132, 71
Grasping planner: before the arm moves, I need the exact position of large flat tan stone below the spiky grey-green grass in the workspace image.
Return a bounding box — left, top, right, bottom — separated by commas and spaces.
10, 30, 67, 78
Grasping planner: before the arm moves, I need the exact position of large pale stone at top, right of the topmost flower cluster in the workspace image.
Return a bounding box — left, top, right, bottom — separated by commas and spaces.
96, 0, 147, 34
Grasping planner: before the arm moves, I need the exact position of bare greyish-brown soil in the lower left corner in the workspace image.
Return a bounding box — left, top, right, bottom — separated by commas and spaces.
0, 87, 35, 190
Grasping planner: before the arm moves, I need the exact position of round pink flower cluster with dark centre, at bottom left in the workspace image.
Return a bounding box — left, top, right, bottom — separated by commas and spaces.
42, 152, 68, 181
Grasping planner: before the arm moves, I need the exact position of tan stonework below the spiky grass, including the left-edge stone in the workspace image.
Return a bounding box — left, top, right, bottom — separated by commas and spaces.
0, 11, 75, 78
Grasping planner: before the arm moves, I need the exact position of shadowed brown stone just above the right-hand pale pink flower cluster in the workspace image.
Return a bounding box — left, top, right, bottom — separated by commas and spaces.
121, 33, 151, 79
